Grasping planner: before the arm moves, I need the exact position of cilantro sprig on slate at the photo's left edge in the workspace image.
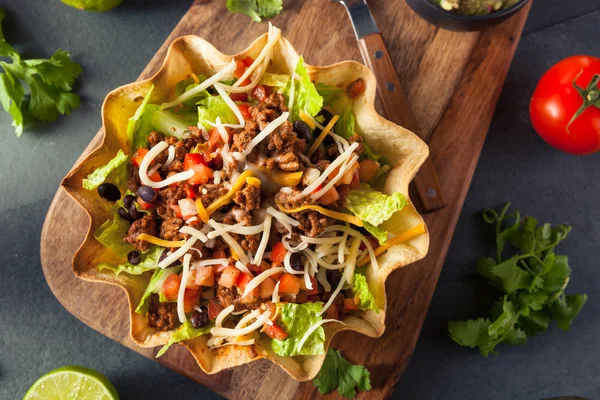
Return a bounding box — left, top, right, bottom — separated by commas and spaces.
0, 8, 83, 136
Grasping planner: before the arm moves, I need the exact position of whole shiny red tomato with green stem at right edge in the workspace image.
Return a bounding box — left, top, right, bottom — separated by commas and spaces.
529, 55, 600, 154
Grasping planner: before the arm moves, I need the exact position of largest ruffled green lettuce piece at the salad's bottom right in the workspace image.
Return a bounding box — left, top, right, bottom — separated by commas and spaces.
271, 303, 325, 356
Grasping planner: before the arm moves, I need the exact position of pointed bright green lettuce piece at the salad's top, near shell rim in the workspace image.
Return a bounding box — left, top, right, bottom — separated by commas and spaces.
283, 56, 323, 121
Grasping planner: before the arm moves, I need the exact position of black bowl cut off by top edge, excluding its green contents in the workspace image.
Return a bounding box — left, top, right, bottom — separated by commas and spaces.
406, 0, 529, 32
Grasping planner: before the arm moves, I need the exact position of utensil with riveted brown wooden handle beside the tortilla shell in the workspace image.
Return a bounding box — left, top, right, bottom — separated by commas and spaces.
330, 0, 447, 212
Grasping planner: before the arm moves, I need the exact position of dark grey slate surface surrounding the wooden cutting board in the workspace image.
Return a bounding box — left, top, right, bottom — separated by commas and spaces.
0, 0, 600, 400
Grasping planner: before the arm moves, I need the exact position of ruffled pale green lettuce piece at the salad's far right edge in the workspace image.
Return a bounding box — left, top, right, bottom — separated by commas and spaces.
345, 184, 407, 243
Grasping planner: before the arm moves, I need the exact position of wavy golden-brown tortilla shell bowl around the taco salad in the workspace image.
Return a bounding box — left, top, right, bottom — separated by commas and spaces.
62, 34, 429, 381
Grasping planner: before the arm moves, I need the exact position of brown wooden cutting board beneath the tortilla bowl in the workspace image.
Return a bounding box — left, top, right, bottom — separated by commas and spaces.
41, 0, 530, 400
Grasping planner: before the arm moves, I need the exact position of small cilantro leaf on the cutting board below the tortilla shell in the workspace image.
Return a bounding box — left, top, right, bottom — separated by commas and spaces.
313, 349, 371, 398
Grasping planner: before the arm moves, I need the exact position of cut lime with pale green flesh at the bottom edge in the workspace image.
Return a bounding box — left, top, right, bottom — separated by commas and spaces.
23, 366, 119, 400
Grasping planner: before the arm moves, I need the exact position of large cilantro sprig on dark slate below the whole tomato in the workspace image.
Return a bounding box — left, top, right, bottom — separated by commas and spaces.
448, 203, 587, 357
